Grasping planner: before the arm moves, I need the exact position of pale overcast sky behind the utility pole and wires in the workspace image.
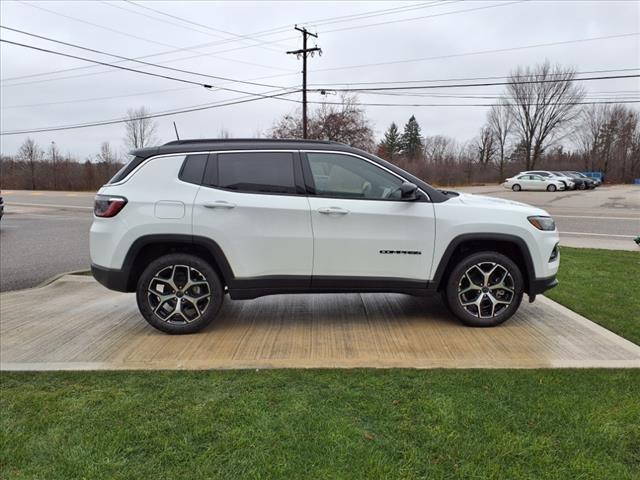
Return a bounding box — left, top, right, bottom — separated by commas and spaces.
0, 0, 640, 158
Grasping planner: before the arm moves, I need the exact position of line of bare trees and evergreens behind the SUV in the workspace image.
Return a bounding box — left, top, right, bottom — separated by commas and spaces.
0, 62, 640, 190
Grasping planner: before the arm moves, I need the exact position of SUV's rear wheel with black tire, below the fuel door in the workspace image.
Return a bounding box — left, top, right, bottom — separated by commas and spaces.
136, 253, 224, 334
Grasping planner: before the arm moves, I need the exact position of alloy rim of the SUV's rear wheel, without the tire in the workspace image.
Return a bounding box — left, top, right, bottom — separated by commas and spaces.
147, 265, 211, 324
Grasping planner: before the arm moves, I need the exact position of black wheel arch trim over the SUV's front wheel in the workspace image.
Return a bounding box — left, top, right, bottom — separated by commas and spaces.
432, 233, 535, 293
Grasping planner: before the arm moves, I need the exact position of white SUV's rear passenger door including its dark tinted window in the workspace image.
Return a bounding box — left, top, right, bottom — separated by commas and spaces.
193, 151, 313, 282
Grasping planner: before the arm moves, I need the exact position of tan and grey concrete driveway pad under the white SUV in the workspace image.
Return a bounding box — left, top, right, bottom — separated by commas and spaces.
0, 276, 640, 370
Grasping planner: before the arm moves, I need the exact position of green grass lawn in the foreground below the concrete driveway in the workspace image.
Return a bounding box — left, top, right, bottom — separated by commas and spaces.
0, 370, 640, 479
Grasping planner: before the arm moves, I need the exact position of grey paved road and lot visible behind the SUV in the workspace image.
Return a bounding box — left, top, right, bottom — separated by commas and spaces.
0, 185, 640, 291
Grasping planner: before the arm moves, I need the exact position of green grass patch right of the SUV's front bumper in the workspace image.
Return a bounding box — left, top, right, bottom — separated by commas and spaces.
545, 247, 640, 345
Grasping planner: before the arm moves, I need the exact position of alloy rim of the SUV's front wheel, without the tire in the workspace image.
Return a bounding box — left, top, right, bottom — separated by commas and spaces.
457, 262, 516, 318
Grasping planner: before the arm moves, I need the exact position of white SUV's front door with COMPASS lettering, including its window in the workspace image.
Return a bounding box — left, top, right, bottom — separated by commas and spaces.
303, 151, 435, 287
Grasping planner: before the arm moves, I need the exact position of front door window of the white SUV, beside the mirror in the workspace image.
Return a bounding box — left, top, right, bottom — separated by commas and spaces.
307, 153, 403, 200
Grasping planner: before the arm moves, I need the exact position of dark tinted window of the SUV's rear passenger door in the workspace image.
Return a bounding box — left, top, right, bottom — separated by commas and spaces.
218, 152, 296, 193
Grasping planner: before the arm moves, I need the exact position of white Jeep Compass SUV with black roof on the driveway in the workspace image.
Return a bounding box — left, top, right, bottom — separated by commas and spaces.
91, 140, 559, 333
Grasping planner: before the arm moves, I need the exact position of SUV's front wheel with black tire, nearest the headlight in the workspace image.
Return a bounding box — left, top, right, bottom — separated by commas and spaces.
445, 252, 524, 327
